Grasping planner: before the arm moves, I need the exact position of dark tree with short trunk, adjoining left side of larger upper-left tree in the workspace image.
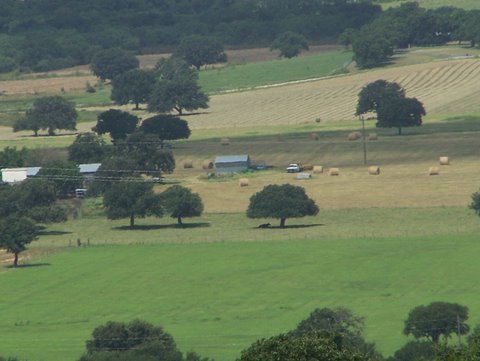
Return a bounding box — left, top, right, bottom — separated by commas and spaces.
111, 69, 155, 110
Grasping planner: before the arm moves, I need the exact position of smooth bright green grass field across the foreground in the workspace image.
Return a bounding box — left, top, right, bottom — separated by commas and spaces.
0, 228, 480, 361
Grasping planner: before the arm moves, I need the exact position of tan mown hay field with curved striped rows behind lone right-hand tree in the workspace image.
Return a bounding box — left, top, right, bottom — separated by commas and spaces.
188, 59, 480, 129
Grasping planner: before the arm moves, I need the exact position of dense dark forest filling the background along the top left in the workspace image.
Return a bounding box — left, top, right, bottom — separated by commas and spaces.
0, 0, 381, 72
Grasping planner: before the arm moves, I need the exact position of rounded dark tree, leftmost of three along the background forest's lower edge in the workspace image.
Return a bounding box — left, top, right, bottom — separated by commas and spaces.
90, 48, 139, 80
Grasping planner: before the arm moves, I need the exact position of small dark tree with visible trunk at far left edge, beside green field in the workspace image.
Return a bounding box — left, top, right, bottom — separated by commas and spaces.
0, 215, 38, 267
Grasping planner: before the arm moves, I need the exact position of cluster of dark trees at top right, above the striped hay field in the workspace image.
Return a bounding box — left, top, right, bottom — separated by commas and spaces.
344, 2, 480, 68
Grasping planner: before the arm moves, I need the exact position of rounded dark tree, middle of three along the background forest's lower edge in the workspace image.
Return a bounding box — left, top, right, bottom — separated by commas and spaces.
174, 35, 227, 69
